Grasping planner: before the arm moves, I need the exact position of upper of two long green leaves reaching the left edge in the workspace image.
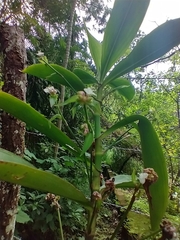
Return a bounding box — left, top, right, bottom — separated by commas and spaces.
0, 91, 80, 155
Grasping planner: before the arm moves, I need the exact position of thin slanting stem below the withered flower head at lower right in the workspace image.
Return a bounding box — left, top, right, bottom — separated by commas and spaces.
110, 187, 139, 240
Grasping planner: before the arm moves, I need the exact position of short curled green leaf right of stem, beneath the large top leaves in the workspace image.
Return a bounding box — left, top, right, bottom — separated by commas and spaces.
109, 78, 135, 101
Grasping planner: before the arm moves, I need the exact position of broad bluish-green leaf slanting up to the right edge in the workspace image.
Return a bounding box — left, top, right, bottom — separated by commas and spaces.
104, 18, 180, 84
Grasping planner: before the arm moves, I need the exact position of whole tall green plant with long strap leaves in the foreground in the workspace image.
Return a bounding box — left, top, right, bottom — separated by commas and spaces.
0, 0, 180, 239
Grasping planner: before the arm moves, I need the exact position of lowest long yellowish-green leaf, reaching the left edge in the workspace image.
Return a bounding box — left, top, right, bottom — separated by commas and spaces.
0, 149, 91, 208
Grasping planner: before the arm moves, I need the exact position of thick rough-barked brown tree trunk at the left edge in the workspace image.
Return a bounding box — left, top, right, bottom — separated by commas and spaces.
0, 24, 26, 240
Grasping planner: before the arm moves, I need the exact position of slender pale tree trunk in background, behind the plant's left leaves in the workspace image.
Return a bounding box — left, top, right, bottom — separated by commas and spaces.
54, 0, 77, 158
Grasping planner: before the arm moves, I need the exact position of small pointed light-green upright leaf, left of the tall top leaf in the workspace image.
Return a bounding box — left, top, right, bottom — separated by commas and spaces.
86, 29, 102, 73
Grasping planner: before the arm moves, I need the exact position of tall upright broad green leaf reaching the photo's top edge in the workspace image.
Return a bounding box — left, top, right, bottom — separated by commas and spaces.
101, 0, 150, 80
